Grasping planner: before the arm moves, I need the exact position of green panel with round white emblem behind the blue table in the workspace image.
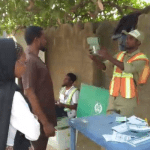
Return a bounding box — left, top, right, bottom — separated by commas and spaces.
77, 84, 109, 118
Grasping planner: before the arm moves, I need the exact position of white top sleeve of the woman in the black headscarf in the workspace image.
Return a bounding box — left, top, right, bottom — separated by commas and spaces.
7, 92, 40, 146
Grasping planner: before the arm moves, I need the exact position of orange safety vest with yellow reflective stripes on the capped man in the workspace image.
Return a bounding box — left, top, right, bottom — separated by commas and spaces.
109, 52, 150, 98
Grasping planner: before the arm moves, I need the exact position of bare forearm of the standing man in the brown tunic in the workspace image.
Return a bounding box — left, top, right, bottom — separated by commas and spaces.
25, 89, 48, 125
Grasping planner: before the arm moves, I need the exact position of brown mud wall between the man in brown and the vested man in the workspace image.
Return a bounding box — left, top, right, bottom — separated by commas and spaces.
45, 22, 117, 99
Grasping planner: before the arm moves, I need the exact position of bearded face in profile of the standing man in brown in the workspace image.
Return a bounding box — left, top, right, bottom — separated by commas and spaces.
39, 31, 47, 51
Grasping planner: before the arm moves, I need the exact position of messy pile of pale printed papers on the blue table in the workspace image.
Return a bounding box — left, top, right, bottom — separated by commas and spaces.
103, 116, 150, 146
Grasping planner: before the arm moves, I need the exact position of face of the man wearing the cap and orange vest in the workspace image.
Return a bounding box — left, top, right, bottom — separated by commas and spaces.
126, 35, 139, 50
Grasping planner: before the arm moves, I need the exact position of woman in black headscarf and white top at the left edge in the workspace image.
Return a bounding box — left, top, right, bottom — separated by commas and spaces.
0, 39, 40, 150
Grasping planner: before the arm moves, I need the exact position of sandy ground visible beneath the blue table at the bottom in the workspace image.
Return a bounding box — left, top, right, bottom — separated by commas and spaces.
47, 133, 101, 150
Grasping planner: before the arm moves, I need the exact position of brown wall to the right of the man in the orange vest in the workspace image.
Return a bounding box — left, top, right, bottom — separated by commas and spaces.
136, 13, 150, 121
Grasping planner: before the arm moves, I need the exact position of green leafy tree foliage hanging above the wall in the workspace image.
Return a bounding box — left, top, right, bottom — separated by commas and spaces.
0, 0, 148, 33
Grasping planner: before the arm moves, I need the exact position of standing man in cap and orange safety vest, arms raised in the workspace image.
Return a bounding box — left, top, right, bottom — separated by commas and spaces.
90, 30, 150, 117
